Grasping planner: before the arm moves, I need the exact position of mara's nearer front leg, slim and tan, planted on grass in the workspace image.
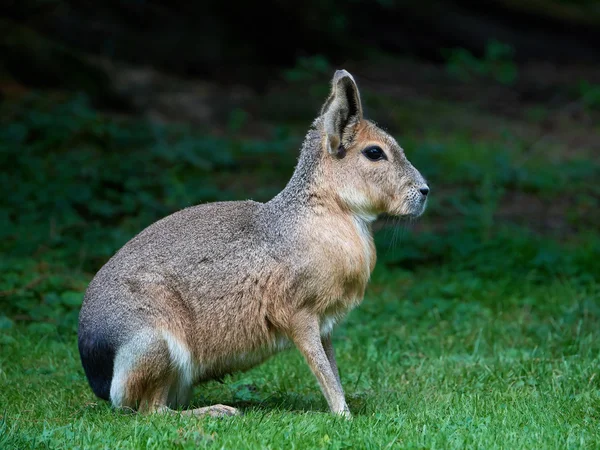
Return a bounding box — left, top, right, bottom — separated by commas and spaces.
290, 311, 351, 417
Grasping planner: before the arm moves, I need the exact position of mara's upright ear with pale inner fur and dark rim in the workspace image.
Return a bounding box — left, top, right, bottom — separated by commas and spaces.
321, 70, 363, 155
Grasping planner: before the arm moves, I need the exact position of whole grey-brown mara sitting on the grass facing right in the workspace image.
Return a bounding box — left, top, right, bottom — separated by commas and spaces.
79, 71, 427, 415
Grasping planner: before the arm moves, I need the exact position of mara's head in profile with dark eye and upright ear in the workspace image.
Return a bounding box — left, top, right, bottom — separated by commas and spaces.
315, 70, 429, 219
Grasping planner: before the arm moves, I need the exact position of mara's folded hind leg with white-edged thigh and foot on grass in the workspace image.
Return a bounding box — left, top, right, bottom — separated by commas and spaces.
110, 330, 238, 416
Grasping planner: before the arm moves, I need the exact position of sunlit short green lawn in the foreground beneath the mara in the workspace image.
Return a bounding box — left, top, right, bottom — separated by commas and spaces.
0, 258, 600, 448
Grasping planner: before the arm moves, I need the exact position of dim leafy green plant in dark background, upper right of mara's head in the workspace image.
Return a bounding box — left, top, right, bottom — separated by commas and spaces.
444, 40, 518, 85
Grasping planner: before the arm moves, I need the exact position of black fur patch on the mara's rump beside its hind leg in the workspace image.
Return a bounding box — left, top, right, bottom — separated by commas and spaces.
78, 330, 116, 400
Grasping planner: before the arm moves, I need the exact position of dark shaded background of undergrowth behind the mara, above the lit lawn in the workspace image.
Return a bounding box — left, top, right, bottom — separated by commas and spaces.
0, 0, 600, 327
